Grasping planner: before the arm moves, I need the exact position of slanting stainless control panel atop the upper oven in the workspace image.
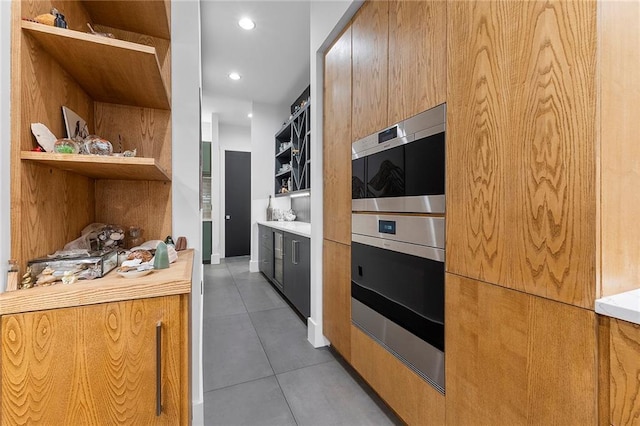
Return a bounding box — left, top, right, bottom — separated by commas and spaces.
351, 104, 446, 160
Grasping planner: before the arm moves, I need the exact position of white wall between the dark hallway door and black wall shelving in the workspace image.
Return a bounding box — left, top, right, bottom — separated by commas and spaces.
249, 100, 293, 272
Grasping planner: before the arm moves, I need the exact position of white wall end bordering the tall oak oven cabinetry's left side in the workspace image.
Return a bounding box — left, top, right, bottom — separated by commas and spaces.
307, 0, 363, 347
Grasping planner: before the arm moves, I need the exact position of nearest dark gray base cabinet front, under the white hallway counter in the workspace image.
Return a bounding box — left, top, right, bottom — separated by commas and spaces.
283, 232, 311, 318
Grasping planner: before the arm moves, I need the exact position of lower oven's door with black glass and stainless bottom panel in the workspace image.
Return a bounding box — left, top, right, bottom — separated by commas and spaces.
351, 234, 444, 393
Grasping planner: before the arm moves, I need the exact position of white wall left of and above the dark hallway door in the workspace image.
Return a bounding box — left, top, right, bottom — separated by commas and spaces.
219, 124, 253, 257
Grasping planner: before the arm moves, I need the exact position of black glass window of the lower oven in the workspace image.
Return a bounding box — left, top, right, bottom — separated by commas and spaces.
351, 242, 444, 351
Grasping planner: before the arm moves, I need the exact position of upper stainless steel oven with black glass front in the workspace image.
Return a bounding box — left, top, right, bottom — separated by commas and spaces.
351, 100, 446, 213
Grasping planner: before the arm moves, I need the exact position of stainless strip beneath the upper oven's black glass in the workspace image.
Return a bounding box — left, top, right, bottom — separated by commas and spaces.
351, 195, 445, 213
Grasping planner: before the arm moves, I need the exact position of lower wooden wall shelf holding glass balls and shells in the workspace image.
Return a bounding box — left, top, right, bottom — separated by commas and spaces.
20, 151, 171, 182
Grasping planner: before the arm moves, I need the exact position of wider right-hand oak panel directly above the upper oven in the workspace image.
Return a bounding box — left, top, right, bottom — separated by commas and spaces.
389, 0, 447, 123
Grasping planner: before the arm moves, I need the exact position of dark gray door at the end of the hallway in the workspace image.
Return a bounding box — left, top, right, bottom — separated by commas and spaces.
224, 151, 251, 257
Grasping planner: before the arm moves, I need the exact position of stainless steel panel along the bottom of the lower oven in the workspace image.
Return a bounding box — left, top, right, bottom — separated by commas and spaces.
351, 298, 444, 394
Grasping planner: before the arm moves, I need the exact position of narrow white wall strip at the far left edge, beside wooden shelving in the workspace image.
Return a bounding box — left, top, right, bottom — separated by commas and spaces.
0, 1, 11, 292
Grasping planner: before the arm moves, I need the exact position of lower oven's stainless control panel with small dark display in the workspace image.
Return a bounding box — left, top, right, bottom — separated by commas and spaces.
351, 213, 445, 249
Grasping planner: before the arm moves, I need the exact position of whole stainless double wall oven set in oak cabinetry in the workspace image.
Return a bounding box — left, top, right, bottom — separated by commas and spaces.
351, 104, 446, 393
